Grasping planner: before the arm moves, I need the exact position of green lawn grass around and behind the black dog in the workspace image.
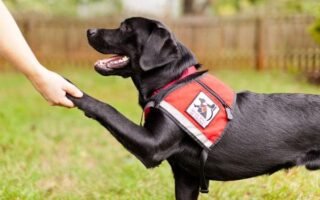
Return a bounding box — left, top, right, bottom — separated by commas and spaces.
0, 68, 320, 200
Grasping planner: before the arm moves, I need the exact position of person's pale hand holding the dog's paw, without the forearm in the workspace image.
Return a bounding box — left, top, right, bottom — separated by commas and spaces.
29, 68, 83, 108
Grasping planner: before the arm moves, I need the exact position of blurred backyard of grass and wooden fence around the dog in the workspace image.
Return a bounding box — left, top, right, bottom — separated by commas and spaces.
0, 0, 320, 200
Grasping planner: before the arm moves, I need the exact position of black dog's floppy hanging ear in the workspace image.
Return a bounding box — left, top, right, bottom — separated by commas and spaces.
139, 24, 179, 71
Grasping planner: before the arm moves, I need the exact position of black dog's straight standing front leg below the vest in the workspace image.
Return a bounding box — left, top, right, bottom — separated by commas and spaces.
171, 165, 199, 200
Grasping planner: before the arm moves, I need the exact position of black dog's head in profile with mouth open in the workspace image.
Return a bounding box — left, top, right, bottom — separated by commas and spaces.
87, 17, 180, 77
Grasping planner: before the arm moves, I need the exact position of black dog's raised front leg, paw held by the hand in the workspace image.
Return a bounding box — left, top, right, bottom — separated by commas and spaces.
68, 94, 179, 168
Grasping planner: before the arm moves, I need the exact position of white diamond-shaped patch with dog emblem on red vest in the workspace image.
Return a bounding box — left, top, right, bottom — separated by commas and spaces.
187, 92, 220, 128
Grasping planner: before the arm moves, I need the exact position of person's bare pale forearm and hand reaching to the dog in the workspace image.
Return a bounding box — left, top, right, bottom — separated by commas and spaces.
0, 0, 83, 108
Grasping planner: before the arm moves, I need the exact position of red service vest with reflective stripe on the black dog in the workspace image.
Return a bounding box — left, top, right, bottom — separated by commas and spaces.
144, 73, 236, 150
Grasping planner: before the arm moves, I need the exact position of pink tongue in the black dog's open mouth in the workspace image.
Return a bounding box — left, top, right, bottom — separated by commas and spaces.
94, 55, 129, 69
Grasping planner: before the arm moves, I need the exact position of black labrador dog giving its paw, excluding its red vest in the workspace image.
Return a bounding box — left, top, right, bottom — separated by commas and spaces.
69, 17, 320, 200
